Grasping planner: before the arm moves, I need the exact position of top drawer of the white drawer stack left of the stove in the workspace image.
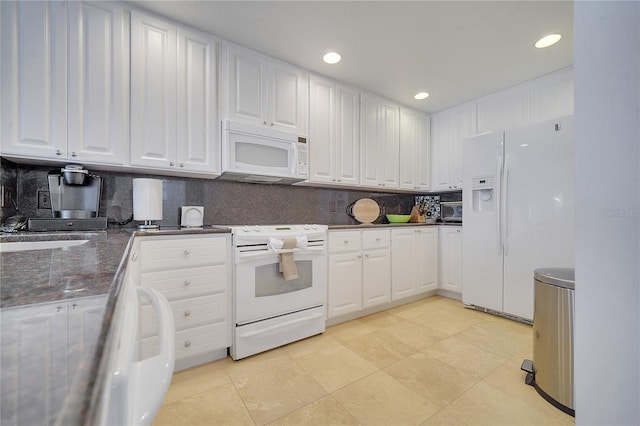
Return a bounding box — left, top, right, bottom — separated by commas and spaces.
140, 237, 227, 271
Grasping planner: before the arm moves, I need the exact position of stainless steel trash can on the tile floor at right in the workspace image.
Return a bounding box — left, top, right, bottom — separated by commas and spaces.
523, 268, 575, 416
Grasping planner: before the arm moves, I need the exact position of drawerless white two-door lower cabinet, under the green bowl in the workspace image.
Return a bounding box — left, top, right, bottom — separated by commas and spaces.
391, 226, 439, 300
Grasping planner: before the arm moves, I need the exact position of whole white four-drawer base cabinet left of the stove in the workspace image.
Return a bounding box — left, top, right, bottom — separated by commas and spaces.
129, 234, 231, 370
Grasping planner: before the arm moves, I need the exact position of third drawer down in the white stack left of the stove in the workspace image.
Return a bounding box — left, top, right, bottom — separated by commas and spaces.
140, 293, 228, 337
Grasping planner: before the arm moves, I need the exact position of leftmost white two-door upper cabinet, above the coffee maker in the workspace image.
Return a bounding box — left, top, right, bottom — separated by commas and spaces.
0, 2, 129, 164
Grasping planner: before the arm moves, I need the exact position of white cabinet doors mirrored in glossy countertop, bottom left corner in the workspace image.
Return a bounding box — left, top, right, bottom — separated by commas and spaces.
0, 296, 106, 426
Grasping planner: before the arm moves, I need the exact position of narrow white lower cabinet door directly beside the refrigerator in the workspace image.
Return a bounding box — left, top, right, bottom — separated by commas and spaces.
440, 226, 462, 293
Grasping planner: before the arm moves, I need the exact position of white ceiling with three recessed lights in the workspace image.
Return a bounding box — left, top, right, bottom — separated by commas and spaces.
130, 0, 573, 113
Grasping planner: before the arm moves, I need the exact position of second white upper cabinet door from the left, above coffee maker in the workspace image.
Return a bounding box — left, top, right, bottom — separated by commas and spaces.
68, 2, 129, 164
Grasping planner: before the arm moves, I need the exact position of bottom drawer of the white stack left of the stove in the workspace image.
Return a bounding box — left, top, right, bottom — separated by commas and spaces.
140, 322, 231, 360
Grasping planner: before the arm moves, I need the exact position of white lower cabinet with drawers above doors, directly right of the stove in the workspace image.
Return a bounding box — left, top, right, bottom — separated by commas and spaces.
327, 229, 391, 318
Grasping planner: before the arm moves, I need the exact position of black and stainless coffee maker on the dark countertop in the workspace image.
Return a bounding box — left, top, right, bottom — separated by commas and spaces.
29, 164, 107, 231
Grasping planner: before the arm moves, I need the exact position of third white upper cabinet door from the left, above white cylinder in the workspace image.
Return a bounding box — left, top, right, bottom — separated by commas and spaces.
131, 12, 177, 168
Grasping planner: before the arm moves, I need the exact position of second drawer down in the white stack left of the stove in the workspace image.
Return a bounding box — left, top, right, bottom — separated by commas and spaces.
140, 265, 228, 301
